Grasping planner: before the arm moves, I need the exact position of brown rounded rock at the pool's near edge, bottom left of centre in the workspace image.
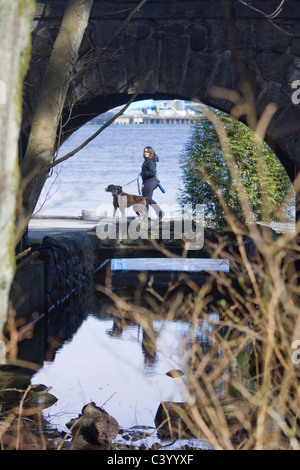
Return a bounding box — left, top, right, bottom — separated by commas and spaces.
66, 402, 119, 446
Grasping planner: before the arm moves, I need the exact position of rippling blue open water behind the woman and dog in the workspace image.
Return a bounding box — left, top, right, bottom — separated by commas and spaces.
36, 124, 191, 217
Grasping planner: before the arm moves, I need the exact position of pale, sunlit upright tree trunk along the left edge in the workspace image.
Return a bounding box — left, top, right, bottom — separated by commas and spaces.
0, 0, 35, 349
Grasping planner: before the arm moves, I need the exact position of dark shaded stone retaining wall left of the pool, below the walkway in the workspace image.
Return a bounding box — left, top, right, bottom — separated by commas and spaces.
11, 233, 94, 320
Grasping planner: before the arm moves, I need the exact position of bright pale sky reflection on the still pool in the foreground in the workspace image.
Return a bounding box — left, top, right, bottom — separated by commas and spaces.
33, 290, 218, 434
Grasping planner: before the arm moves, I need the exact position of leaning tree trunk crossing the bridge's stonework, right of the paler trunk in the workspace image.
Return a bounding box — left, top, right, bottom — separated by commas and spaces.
15, 0, 93, 243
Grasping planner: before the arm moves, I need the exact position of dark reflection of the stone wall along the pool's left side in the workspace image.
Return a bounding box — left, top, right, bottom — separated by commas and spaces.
0, 283, 94, 411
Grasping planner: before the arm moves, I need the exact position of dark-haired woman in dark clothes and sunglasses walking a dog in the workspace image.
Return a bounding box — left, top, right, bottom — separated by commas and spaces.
141, 147, 164, 219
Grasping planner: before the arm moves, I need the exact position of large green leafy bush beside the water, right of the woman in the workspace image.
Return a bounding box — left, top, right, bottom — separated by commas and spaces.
179, 111, 293, 226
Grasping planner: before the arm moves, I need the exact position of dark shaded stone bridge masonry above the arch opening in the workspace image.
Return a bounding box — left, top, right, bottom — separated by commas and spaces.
22, 0, 300, 185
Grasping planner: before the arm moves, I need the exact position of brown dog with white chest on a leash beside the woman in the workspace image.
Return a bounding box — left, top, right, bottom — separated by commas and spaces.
105, 184, 148, 218
